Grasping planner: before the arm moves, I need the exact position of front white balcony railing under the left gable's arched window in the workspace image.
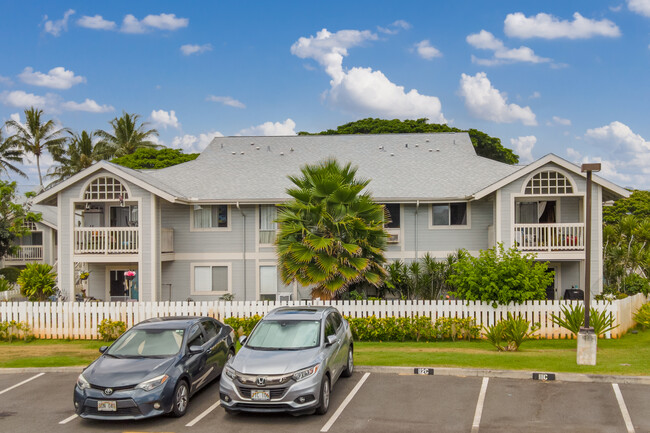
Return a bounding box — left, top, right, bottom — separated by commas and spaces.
74, 227, 140, 254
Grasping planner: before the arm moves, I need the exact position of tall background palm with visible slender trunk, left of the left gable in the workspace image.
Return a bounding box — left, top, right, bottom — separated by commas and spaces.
5, 107, 68, 188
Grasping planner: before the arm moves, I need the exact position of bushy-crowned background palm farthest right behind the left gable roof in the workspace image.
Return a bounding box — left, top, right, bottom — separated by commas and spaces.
96, 112, 160, 159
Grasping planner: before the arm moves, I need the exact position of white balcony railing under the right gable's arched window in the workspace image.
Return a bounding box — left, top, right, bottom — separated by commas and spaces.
514, 223, 585, 251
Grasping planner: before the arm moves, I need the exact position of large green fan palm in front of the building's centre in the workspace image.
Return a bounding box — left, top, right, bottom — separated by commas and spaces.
276, 160, 387, 297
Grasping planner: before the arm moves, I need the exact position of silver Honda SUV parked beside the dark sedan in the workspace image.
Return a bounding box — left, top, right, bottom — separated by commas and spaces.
219, 307, 354, 415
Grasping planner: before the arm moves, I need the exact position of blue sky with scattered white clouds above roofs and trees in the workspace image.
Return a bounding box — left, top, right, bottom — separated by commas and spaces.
0, 0, 650, 189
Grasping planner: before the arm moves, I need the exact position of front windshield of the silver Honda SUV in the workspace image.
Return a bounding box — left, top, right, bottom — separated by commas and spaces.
246, 320, 320, 350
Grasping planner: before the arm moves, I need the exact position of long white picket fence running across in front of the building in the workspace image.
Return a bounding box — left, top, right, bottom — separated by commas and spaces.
0, 295, 648, 339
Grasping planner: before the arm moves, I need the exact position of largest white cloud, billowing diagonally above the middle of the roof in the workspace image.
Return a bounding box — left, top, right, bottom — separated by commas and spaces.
291, 29, 445, 122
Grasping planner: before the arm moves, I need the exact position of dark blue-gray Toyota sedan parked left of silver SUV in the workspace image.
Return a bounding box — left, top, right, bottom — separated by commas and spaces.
74, 317, 235, 419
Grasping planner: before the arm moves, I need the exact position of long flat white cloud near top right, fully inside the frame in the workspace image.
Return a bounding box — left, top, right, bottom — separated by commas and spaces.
503, 12, 621, 39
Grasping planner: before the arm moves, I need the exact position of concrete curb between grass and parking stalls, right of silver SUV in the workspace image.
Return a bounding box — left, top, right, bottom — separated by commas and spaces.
356, 365, 650, 385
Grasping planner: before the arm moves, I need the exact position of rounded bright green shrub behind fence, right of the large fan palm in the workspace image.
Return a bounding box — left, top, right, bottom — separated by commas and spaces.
449, 244, 553, 307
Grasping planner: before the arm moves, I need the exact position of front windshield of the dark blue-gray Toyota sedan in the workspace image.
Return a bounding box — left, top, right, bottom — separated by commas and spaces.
106, 329, 185, 358
